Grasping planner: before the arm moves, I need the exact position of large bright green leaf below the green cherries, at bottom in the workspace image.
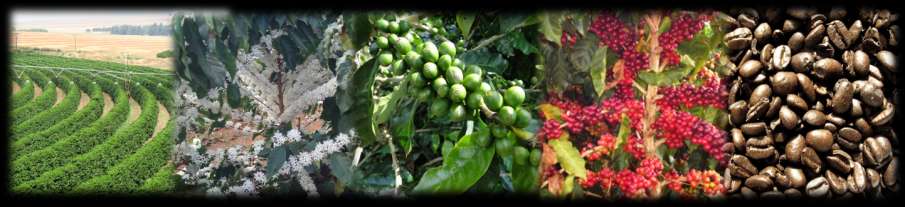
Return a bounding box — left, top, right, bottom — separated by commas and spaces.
413, 131, 494, 195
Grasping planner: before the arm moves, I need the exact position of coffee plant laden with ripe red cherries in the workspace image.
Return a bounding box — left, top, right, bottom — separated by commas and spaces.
537, 10, 728, 199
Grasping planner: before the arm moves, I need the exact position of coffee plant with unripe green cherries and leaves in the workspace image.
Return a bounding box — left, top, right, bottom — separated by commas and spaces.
337, 12, 540, 196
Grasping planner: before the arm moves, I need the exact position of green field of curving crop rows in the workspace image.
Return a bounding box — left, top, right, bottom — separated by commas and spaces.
9, 51, 175, 194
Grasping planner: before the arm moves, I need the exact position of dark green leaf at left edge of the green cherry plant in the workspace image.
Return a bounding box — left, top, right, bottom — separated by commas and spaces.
336, 59, 378, 145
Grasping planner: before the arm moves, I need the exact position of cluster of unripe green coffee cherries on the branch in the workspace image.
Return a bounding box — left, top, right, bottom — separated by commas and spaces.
374, 19, 532, 161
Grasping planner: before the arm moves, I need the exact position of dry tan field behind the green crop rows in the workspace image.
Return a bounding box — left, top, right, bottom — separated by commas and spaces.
9, 32, 173, 70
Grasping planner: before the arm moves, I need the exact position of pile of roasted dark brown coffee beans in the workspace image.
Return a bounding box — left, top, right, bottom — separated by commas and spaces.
724, 7, 899, 199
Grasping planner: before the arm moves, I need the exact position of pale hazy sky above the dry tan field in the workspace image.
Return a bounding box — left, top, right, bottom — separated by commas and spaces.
12, 9, 185, 33
